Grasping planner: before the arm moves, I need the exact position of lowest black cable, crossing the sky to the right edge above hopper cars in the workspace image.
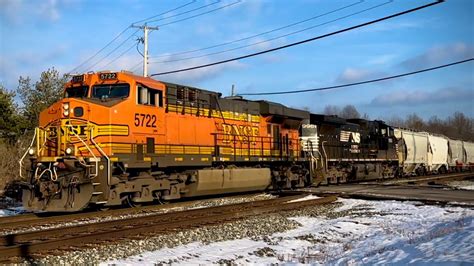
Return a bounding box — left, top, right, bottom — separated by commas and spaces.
238, 58, 474, 96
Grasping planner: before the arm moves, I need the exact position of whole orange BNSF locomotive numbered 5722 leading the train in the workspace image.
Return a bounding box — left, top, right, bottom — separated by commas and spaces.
20, 72, 318, 212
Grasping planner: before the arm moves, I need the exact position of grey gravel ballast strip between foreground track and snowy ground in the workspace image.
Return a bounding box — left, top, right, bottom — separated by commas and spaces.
25, 197, 340, 265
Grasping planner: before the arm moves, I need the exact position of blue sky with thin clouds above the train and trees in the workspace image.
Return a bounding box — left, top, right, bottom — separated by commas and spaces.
0, 0, 474, 119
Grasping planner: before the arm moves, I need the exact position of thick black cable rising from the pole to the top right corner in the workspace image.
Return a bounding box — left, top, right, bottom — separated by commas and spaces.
150, 0, 444, 77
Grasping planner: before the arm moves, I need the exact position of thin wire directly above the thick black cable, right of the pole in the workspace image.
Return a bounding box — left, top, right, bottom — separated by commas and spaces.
150, 0, 393, 64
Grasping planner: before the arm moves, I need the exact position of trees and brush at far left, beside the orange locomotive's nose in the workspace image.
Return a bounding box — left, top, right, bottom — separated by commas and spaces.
0, 68, 67, 190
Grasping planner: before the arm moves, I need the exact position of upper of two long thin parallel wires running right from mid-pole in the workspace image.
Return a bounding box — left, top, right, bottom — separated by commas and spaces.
150, 0, 364, 58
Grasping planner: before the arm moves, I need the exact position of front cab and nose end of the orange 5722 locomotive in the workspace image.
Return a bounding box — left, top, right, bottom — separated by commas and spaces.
20, 72, 168, 211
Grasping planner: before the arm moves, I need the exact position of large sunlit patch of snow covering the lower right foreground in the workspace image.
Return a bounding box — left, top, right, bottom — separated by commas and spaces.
104, 199, 474, 265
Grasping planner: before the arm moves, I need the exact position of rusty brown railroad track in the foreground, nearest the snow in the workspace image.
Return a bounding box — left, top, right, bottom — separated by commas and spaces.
0, 194, 337, 262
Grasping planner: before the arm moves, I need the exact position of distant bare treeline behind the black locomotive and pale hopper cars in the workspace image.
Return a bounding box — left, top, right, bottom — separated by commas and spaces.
324, 105, 474, 141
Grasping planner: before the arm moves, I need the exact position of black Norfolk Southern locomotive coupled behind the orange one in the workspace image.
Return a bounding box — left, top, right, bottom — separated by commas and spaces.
302, 114, 398, 184
